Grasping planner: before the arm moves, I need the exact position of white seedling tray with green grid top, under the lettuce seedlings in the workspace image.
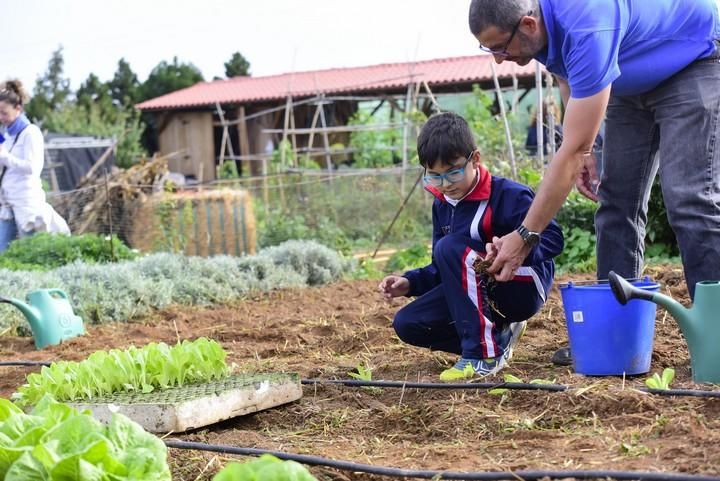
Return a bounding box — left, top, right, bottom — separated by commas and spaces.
70, 373, 302, 433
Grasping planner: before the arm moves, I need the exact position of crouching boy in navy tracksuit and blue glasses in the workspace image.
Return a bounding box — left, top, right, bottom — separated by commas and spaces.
379, 113, 563, 381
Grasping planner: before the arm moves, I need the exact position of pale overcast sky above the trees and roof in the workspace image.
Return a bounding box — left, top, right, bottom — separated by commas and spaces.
7, 0, 478, 90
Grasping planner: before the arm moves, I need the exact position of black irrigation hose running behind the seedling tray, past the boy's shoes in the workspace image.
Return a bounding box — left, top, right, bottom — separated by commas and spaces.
0, 361, 720, 398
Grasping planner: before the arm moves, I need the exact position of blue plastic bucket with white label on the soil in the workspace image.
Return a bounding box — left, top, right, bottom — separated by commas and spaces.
560, 278, 659, 376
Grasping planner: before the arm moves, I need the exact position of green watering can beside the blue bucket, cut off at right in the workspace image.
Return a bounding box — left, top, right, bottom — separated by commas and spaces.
608, 271, 720, 384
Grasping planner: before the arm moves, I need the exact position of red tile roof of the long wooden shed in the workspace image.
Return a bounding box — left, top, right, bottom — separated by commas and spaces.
137, 55, 535, 110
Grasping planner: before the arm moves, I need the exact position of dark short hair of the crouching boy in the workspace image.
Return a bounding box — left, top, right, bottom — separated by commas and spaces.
418, 112, 475, 168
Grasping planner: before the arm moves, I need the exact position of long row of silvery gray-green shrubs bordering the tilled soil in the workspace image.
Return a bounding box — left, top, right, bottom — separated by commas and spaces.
0, 241, 347, 332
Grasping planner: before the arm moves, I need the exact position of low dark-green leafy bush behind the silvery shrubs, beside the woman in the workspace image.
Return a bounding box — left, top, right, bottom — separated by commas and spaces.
0, 233, 137, 271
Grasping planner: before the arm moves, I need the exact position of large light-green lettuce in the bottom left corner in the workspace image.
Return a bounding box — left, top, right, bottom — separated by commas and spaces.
0, 396, 171, 481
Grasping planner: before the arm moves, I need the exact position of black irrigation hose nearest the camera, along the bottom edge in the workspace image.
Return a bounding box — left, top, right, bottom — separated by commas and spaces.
165, 439, 720, 481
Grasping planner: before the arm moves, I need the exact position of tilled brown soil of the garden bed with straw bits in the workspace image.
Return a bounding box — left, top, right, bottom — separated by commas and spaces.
0, 266, 720, 480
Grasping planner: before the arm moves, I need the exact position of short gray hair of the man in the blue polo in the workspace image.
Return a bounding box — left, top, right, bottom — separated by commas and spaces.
468, 0, 540, 35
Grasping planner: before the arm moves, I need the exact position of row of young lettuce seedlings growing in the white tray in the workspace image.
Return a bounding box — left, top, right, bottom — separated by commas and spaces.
13, 337, 230, 405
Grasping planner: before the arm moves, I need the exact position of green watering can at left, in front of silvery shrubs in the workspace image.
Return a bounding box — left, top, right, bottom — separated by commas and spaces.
0, 289, 85, 349
